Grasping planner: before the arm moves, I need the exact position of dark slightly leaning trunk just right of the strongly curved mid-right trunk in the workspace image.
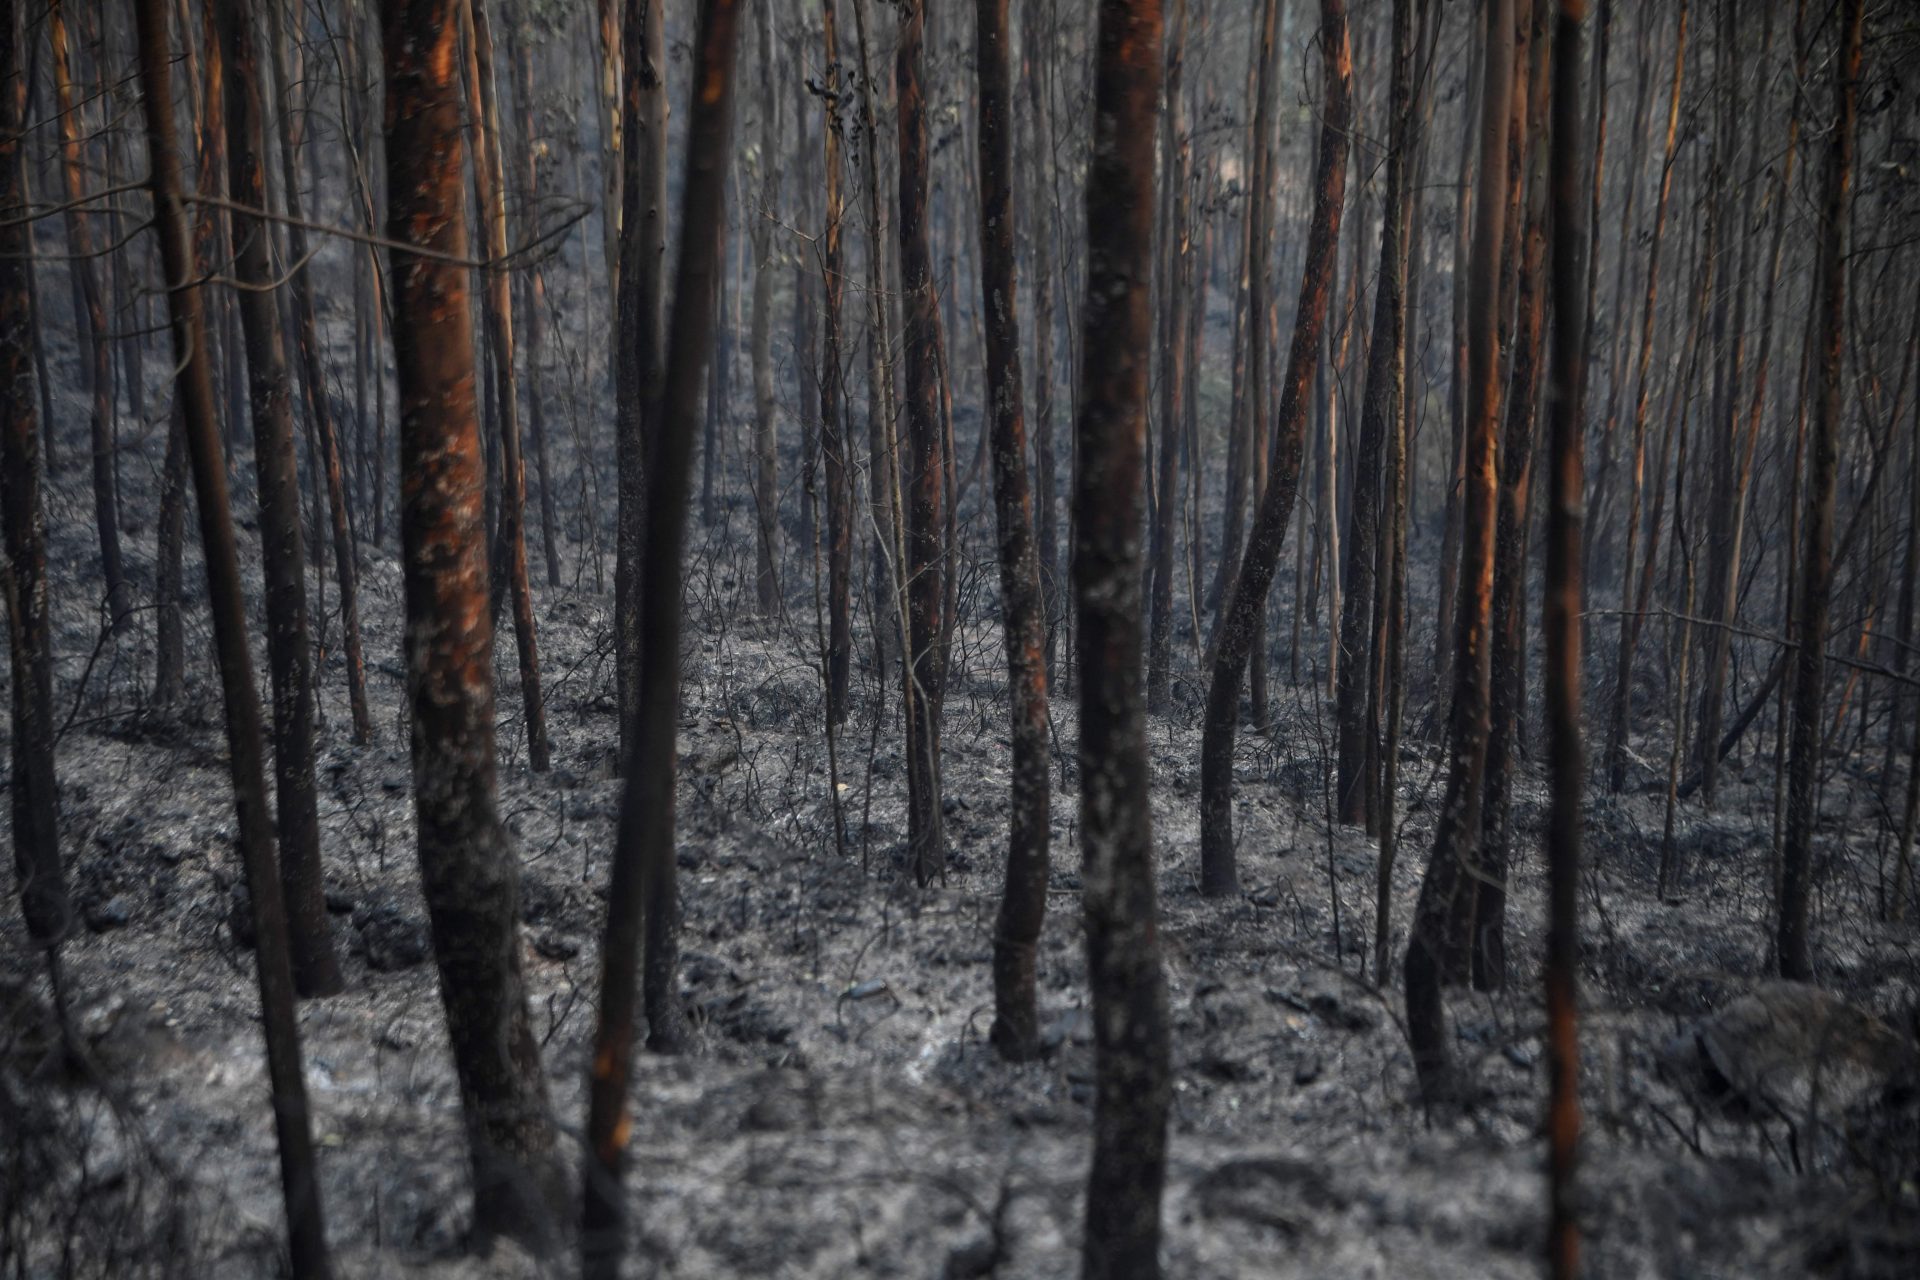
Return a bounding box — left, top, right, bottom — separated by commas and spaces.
1334, 0, 1413, 827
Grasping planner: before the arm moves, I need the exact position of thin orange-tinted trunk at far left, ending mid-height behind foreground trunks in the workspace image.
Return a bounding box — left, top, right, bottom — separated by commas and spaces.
46, 0, 132, 633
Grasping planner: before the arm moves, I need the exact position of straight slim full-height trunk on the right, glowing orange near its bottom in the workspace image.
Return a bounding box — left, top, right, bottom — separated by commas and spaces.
1540, 0, 1605, 1280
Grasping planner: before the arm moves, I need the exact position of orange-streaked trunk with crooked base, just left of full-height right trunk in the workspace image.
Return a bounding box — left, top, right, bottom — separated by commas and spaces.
1405, 0, 1515, 1100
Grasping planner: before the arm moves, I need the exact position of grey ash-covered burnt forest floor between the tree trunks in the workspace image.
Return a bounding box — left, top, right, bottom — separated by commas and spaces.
0, 393, 1920, 1278
